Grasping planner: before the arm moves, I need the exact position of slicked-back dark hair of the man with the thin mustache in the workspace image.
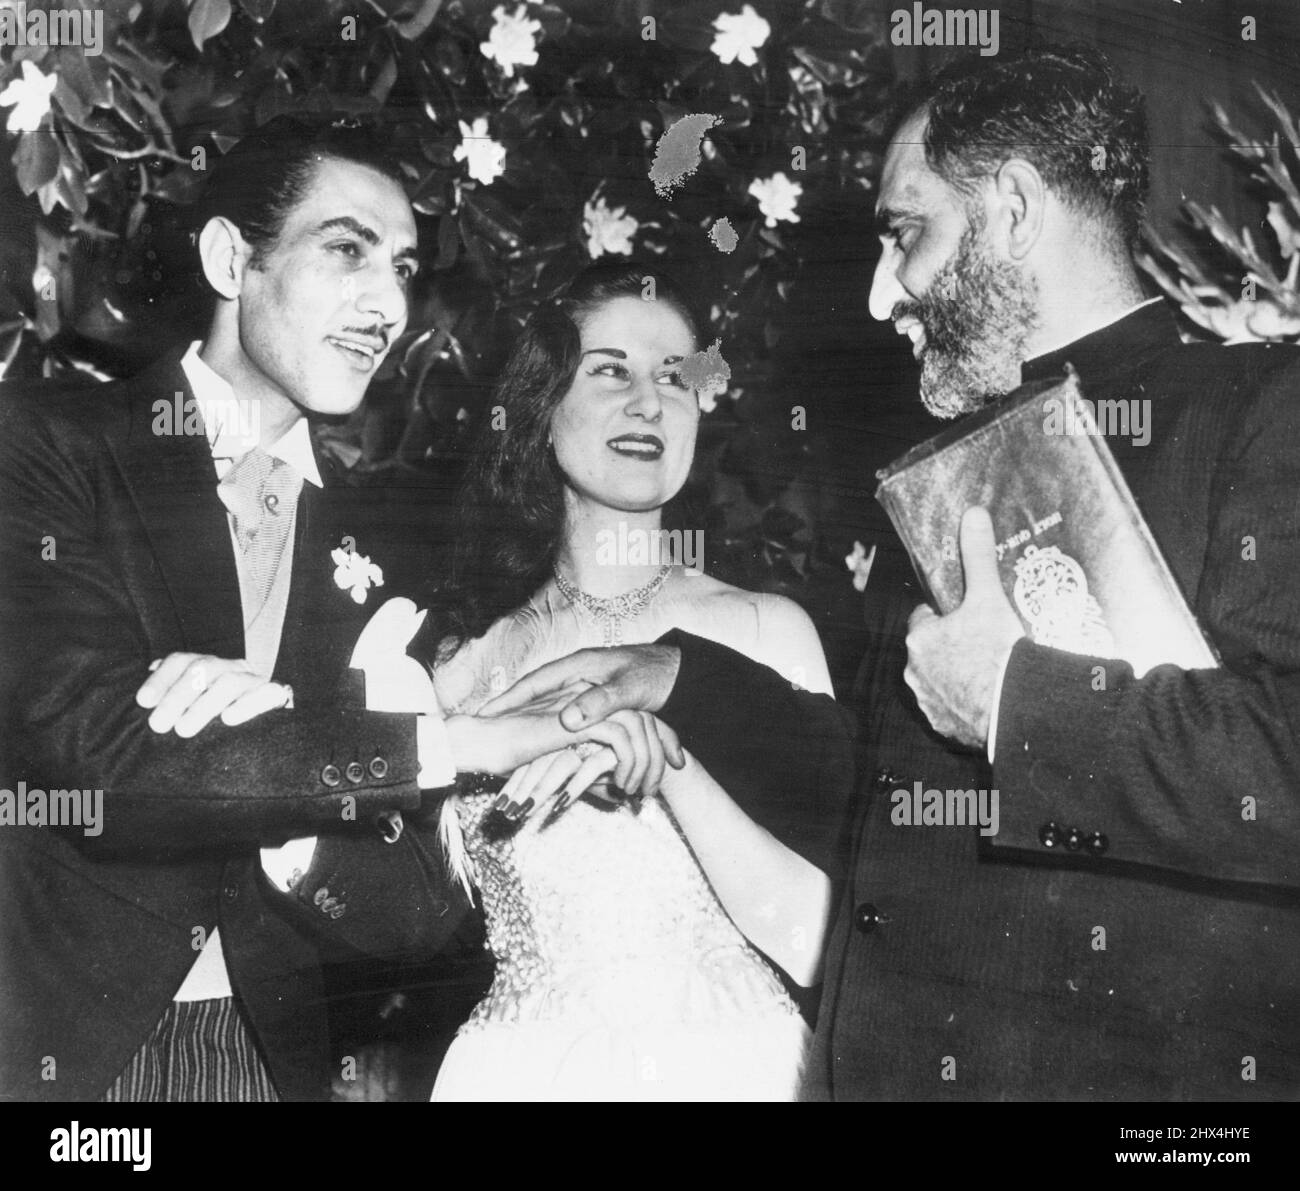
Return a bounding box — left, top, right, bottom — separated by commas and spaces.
194, 114, 403, 268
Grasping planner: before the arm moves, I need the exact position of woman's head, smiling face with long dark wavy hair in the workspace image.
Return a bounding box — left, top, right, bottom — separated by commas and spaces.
430, 261, 705, 653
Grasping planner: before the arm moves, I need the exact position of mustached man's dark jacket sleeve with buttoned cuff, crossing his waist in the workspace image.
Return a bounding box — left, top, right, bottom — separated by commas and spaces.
0, 382, 447, 852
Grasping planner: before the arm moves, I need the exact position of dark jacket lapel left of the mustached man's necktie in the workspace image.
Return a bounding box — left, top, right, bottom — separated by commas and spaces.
109, 356, 244, 658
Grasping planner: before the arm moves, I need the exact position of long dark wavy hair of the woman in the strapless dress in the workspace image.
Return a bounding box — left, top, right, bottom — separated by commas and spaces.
429, 261, 706, 659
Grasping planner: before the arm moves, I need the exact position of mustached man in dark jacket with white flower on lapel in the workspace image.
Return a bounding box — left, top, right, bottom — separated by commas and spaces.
0, 118, 670, 1100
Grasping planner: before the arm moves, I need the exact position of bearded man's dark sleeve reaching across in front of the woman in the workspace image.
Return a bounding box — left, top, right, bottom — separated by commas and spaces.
659, 629, 854, 879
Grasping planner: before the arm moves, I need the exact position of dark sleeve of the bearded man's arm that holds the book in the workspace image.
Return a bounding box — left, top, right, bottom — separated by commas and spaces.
993, 348, 1300, 889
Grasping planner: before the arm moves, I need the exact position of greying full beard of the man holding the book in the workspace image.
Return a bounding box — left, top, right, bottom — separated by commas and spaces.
893, 220, 1037, 419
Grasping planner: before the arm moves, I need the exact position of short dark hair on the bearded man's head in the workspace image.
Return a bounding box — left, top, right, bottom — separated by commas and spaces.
898, 46, 1151, 248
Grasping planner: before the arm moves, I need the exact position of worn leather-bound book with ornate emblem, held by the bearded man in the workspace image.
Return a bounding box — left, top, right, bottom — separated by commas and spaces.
876, 374, 1218, 675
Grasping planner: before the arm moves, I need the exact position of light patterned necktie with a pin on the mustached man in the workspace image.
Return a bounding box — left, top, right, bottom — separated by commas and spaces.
217, 446, 303, 627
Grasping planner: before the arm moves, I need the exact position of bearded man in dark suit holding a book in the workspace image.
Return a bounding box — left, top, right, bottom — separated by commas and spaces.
488, 49, 1300, 1100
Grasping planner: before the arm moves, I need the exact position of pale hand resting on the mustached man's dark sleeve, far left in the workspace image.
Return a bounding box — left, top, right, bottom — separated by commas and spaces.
135, 653, 294, 737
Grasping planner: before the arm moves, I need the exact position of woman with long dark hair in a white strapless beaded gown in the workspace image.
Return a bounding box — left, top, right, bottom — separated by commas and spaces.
416, 263, 829, 1100
